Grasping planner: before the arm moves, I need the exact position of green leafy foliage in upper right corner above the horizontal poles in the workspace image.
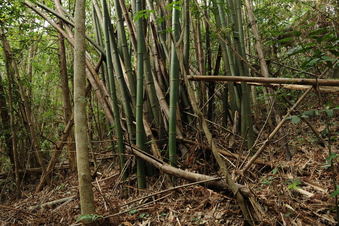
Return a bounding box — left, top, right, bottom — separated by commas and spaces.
254, 0, 339, 77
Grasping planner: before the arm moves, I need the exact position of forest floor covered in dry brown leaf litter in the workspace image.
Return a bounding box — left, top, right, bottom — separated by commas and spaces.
0, 92, 339, 226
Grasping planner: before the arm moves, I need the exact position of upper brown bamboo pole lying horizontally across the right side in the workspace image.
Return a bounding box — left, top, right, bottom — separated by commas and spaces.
188, 75, 339, 86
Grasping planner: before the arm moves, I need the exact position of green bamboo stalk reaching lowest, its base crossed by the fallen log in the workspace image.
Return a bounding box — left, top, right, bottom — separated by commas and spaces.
135, 0, 146, 188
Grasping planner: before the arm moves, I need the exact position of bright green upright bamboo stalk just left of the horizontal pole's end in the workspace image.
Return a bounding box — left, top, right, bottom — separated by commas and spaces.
168, 0, 180, 165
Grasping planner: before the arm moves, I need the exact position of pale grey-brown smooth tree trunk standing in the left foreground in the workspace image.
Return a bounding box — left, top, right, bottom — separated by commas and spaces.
74, 0, 95, 215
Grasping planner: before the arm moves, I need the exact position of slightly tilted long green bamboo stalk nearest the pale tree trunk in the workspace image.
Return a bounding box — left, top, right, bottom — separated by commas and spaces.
102, 0, 126, 169
